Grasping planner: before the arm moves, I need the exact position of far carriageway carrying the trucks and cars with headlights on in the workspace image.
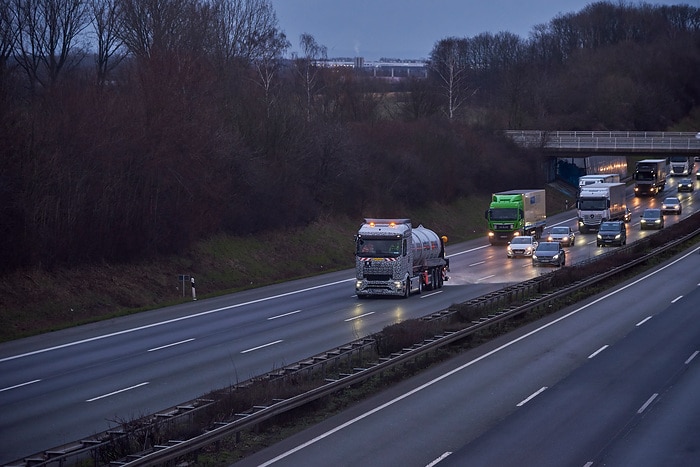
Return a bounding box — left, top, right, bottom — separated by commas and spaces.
0, 178, 700, 463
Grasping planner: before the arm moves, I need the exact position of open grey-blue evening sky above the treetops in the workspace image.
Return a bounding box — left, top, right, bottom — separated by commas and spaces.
270, 0, 700, 60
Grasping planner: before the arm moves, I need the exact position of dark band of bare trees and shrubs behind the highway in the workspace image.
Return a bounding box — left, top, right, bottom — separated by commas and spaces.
0, 0, 700, 271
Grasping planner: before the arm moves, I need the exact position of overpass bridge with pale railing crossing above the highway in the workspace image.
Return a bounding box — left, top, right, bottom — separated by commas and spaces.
505, 130, 700, 155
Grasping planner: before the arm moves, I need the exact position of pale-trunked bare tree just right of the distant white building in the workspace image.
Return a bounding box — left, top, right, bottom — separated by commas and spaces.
428, 37, 468, 120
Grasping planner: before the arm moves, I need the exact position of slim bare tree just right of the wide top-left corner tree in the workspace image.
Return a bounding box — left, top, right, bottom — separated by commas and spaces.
90, 0, 126, 84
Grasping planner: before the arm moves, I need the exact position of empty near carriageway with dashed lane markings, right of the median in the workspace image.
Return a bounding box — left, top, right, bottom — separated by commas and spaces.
236, 239, 700, 467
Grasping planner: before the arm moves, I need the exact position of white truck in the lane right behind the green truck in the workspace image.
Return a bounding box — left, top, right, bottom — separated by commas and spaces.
576, 183, 627, 233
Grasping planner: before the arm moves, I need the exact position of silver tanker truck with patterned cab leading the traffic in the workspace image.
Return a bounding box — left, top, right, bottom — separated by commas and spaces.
355, 219, 450, 298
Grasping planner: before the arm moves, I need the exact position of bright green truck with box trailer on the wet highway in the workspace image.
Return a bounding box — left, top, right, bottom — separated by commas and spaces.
485, 190, 547, 245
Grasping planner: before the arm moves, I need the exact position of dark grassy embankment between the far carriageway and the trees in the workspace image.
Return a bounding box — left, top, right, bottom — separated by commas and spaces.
0, 191, 576, 342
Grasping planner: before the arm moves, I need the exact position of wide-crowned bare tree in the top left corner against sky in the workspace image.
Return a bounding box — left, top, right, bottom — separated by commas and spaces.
8, 0, 89, 88
